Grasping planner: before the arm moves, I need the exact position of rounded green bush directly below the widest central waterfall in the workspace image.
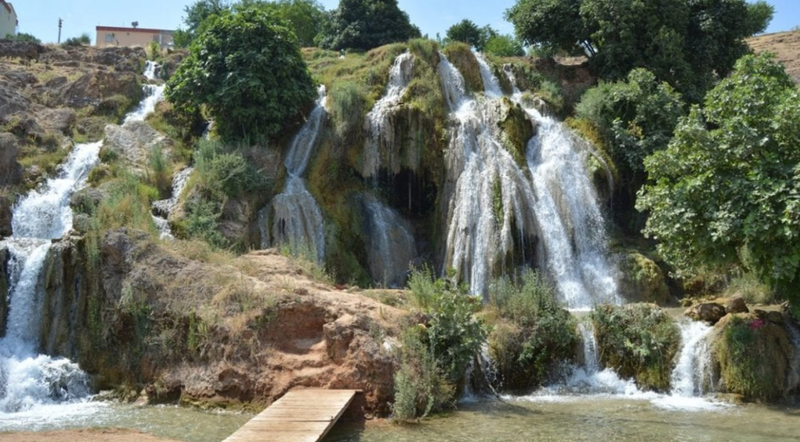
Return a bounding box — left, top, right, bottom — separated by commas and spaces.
489, 270, 578, 391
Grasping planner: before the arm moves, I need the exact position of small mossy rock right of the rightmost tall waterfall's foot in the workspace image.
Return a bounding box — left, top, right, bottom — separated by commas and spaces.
620, 251, 669, 304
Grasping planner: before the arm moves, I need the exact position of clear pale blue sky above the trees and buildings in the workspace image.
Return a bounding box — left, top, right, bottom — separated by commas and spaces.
7, 0, 800, 43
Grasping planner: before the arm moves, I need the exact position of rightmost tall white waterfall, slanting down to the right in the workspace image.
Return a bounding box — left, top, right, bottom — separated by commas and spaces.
507, 67, 622, 309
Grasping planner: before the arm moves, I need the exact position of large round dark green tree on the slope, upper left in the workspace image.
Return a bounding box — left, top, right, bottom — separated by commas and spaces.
166, 7, 315, 139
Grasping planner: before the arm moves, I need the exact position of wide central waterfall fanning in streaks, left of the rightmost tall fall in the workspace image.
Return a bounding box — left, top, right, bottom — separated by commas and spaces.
439, 53, 537, 294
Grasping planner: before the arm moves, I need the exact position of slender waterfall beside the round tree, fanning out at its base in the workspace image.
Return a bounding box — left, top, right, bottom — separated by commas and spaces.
259, 86, 328, 262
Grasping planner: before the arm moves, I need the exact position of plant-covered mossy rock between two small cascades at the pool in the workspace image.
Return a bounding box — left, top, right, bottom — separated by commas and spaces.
592, 304, 681, 392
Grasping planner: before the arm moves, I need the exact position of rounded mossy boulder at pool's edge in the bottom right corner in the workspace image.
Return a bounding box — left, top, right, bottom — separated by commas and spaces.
709, 312, 800, 401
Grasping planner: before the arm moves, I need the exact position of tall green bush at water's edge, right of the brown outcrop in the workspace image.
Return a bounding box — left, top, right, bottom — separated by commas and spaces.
393, 268, 488, 422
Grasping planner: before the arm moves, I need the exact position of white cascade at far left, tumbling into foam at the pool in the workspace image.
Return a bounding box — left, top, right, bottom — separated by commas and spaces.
0, 142, 102, 413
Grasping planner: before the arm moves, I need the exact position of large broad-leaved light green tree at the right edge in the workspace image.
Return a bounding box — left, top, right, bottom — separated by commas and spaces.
638, 55, 800, 291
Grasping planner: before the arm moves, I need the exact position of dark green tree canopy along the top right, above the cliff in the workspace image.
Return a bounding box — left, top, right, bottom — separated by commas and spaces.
506, 0, 773, 102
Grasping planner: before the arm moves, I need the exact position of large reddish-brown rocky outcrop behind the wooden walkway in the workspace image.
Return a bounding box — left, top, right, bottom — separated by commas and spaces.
36, 229, 400, 413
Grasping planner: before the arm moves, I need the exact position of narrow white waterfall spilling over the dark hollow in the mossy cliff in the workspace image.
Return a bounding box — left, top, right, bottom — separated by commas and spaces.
361, 52, 414, 178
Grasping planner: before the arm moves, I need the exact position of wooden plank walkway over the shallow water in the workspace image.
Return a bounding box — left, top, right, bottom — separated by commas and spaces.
223, 389, 360, 442
